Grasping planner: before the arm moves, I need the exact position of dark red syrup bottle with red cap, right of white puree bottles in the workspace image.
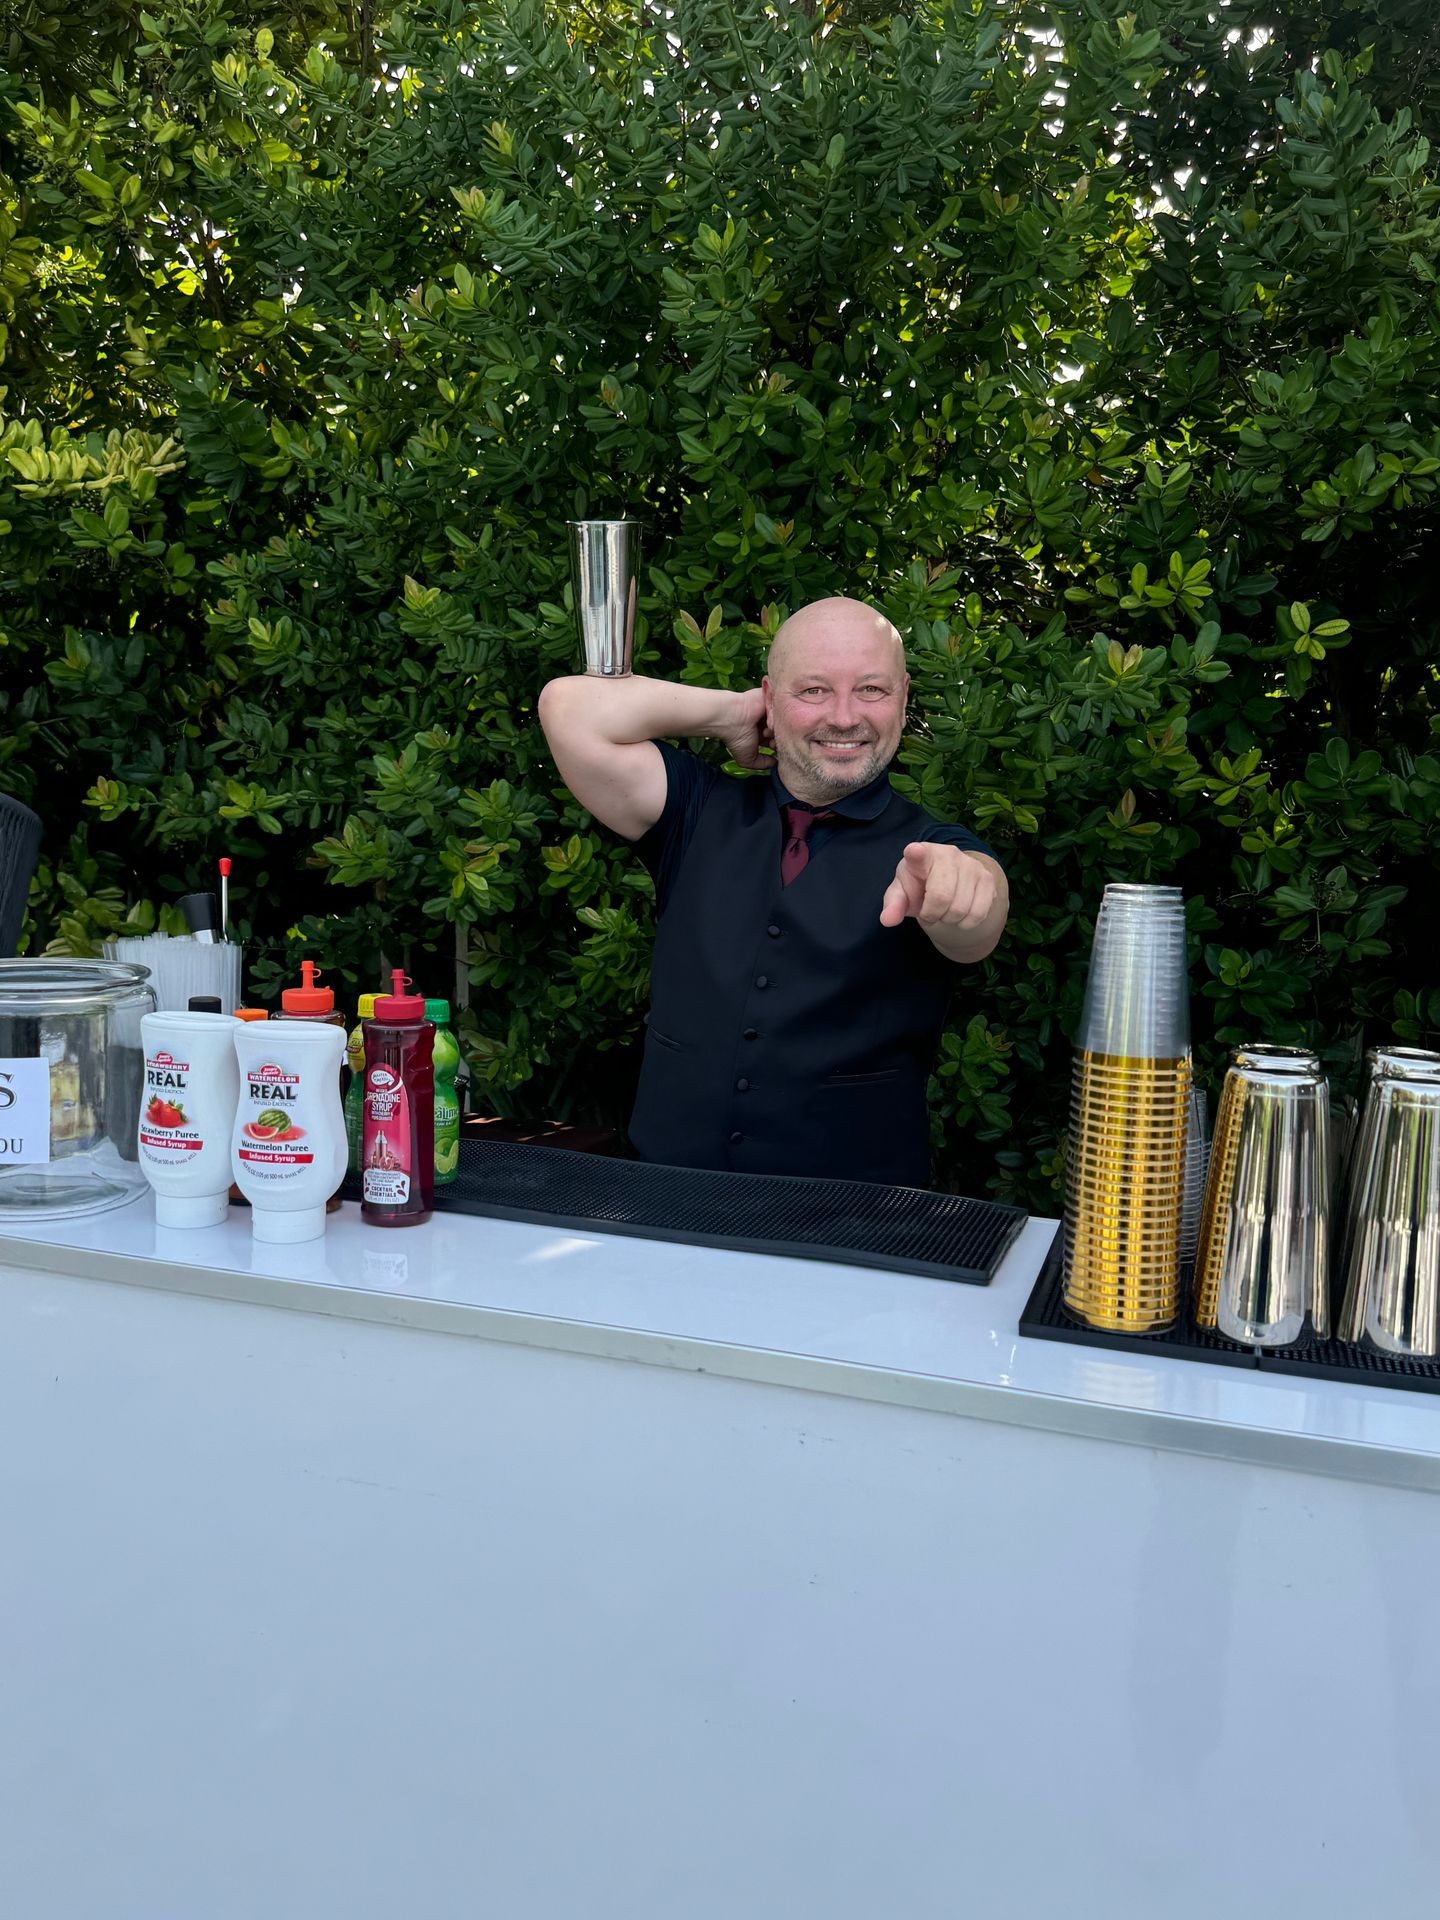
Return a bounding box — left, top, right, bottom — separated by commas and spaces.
361, 968, 436, 1227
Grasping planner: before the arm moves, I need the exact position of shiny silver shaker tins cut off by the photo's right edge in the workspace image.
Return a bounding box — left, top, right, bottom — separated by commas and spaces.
1340, 1046, 1440, 1359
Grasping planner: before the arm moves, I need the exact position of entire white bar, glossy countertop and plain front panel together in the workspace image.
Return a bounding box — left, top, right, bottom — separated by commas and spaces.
0, 1198, 1440, 1920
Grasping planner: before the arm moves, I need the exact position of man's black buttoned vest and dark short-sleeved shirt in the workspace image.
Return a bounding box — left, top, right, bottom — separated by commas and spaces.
630, 778, 952, 1187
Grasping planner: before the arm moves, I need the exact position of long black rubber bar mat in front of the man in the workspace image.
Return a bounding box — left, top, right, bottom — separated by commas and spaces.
346, 1140, 1025, 1286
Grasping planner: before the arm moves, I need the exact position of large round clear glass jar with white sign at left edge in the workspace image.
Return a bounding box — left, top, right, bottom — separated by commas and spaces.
0, 960, 156, 1221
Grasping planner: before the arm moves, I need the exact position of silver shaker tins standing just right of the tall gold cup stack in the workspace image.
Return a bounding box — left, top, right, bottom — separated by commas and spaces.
1194, 1046, 1331, 1346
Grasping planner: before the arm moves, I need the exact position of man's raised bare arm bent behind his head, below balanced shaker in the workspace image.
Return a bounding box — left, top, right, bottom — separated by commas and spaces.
540, 674, 764, 839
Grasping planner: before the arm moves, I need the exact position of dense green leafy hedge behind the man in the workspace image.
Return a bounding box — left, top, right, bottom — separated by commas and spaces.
0, 0, 1440, 1198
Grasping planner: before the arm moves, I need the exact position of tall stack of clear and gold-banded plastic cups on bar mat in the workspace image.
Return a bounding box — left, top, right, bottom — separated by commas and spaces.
1064, 885, 1190, 1332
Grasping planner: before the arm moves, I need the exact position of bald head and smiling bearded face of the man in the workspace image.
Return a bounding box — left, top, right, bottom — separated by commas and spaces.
762, 599, 910, 806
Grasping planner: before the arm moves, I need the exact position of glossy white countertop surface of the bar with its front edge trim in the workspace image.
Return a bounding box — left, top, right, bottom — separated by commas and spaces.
0, 1196, 1440, 1492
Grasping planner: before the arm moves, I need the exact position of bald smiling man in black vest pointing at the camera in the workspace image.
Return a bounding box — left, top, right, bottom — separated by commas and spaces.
540, 597, 1008, 1187
